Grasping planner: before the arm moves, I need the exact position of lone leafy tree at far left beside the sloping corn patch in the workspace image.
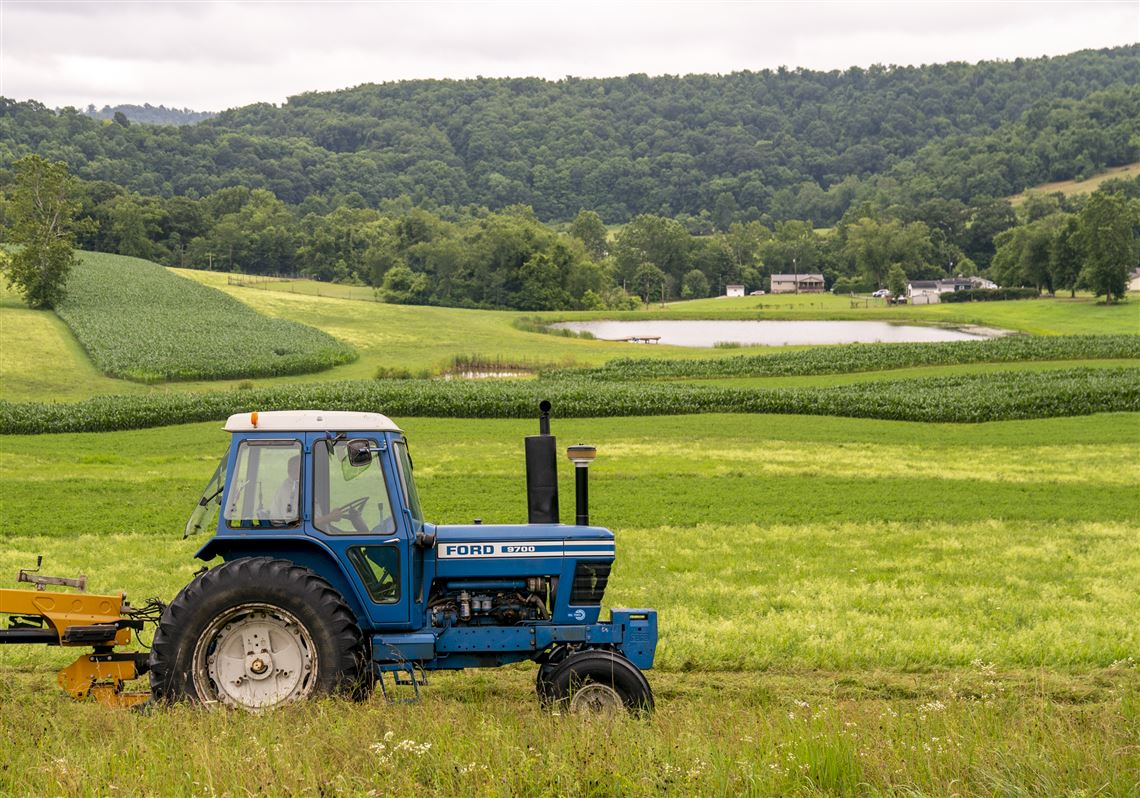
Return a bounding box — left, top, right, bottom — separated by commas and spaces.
5, 155, 79, 308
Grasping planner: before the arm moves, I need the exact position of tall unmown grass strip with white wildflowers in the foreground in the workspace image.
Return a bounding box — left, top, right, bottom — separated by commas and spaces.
0, 668, 1140, 798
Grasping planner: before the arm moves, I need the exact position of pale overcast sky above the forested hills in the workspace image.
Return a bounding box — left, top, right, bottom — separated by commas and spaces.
0, 0, 1140, 111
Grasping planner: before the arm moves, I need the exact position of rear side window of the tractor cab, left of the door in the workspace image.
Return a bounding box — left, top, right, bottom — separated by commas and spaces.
225, 440, 301, 527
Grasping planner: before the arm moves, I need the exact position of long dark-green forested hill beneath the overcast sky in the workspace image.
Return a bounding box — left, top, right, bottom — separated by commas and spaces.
0, 46, 1140, 225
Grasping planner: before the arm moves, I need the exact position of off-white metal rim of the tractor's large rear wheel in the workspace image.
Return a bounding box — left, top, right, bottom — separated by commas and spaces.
194, 604, 317, 710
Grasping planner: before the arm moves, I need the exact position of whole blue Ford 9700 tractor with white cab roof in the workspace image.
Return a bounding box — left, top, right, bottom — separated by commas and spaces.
148, 401, 657, 711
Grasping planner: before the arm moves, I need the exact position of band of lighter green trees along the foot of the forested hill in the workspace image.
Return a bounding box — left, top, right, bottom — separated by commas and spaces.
3, 156, 1140, 310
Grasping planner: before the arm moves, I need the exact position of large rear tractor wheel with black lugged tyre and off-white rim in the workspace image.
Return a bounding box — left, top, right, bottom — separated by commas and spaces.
150, 557, 366, 710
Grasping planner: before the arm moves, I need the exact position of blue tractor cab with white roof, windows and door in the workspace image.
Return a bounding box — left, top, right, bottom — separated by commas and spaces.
186, 410, 425, 628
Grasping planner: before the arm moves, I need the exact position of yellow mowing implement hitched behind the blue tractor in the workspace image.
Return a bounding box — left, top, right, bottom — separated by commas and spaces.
0, 558, 150, 707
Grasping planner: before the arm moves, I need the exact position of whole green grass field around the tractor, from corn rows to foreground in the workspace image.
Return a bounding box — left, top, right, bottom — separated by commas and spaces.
0, 414, 1140, 796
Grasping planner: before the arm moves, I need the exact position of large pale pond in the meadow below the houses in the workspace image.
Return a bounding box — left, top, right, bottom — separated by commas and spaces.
551, 320, 1005, 348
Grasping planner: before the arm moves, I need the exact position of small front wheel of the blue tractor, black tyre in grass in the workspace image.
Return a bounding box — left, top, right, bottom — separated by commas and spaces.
540, 650, 653, 714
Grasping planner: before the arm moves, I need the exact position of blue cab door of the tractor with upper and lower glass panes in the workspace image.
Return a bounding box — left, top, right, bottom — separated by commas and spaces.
304, 432, 412, 629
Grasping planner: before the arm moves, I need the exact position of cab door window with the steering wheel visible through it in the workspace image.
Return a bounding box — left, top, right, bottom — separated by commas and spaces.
312, 440, 396, 535
